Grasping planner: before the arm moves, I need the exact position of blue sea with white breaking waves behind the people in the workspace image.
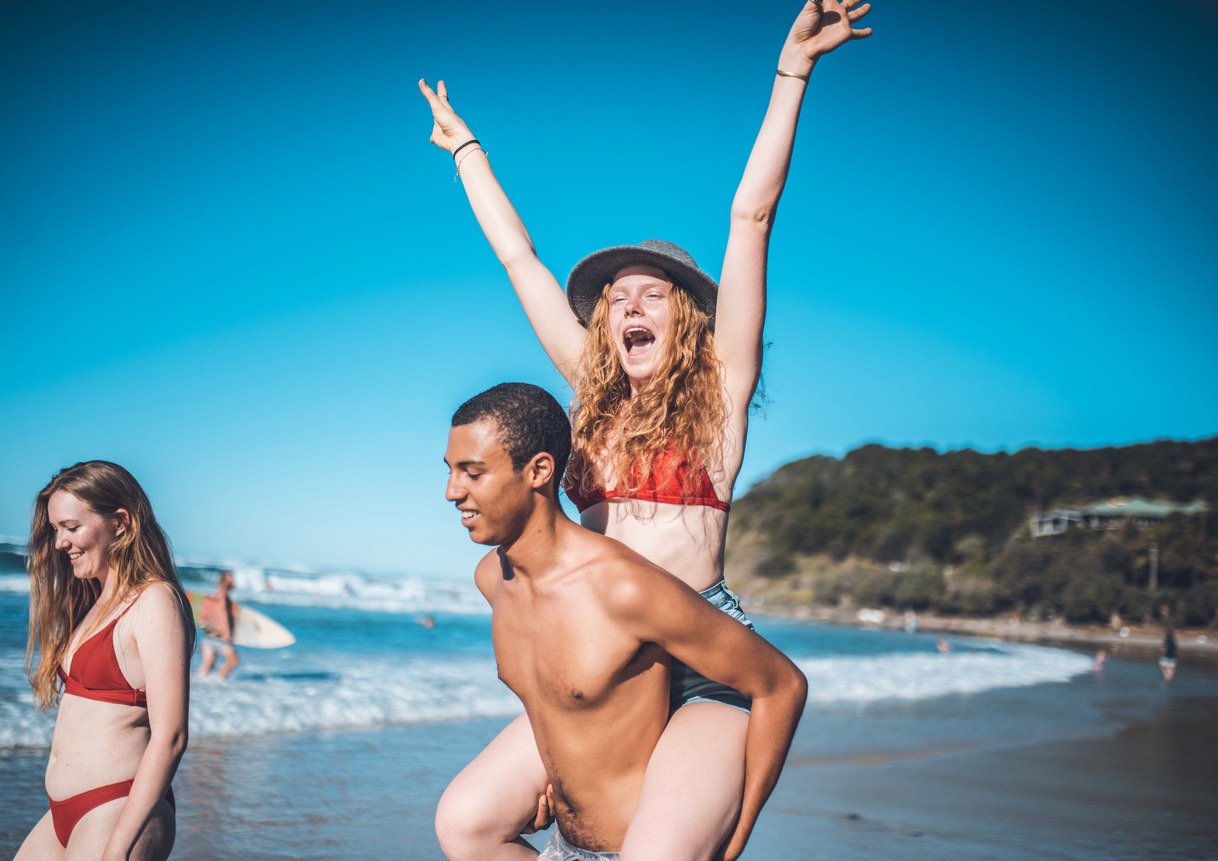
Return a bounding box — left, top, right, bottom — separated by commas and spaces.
0, 555, 1090, 749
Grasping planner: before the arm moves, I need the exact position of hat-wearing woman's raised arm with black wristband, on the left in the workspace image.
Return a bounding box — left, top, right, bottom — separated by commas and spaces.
419, 80, 585, 385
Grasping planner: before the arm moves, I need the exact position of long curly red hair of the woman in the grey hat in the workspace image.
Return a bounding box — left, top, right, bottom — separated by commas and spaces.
568, 284, 727, 496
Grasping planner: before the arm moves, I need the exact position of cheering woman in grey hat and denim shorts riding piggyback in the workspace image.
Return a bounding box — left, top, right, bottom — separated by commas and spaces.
419, 0, 871, 861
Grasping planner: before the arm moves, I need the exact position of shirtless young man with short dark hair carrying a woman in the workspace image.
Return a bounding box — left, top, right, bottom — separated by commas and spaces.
445, 384, 808, 860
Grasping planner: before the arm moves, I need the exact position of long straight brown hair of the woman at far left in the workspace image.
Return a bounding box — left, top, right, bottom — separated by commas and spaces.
26, 460, 195, 709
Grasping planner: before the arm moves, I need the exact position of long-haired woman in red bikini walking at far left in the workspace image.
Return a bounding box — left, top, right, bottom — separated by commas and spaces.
16, 460, 195, 861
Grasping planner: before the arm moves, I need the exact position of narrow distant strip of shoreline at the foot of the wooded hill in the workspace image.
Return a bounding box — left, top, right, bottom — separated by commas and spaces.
743, 598, 1218, 665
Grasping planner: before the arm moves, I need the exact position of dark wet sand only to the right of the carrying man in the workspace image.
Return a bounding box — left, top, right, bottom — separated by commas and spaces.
745, 694, 1218, 861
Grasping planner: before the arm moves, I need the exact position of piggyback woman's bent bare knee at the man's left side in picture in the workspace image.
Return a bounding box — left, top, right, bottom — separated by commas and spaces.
436, 715, 547, 861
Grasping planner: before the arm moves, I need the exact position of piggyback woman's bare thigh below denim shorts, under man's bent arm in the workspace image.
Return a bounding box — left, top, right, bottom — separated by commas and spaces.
621, 703, 749, 861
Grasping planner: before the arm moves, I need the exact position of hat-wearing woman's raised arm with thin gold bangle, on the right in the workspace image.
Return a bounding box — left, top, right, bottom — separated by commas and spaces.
715, 0, 871, 410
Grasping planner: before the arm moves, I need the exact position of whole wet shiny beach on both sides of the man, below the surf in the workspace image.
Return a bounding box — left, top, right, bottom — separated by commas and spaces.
0, 638, 1218, 861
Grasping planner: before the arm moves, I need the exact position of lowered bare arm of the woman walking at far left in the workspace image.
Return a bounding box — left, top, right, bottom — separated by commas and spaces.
102, 583, 190, 861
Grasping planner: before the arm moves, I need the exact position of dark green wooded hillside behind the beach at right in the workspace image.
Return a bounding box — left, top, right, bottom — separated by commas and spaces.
727, 437, 1218, 625
